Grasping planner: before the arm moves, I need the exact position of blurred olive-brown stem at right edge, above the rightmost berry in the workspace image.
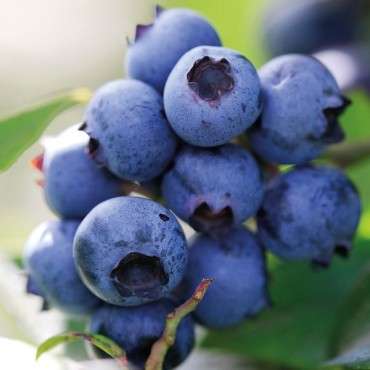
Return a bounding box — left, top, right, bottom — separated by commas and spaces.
324, 139, 370, 168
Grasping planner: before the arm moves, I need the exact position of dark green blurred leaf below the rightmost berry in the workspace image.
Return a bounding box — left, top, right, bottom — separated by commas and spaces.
202, 240, 370, 370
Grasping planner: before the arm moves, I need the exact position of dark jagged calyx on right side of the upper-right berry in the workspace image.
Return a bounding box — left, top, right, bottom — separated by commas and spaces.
322, 96, 351, 144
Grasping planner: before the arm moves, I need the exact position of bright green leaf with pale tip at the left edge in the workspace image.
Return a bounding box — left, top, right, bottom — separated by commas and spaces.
0, 88, 91, 172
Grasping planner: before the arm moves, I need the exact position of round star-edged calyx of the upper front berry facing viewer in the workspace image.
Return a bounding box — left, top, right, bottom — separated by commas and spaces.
187, 56, 235, 101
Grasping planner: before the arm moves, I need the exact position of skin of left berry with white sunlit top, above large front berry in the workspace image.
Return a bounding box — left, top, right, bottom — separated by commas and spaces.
43, 129, 122, 218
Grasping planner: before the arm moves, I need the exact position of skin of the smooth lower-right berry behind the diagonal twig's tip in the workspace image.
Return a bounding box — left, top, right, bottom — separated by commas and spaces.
182, 227, 269, 329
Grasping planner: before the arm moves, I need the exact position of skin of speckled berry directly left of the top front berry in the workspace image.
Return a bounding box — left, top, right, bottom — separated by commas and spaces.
85, 80, 177, 181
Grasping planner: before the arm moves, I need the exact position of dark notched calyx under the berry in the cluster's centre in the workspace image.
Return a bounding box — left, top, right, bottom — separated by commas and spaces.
190, 202, 234, 231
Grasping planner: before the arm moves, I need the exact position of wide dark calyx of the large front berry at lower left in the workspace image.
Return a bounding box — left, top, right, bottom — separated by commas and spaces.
111, 252, 168, 297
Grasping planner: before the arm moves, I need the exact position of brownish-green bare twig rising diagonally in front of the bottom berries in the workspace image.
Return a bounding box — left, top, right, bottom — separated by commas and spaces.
145, 279, 213, 370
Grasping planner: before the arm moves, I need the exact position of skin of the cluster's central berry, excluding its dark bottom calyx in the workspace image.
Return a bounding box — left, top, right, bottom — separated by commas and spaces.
162, 144, 264, 231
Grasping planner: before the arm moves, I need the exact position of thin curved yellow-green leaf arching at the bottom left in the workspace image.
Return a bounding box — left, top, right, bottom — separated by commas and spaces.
36, 331, 126, 365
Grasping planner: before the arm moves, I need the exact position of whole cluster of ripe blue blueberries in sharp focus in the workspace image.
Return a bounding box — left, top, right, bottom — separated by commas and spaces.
25, 8, 361, 369
